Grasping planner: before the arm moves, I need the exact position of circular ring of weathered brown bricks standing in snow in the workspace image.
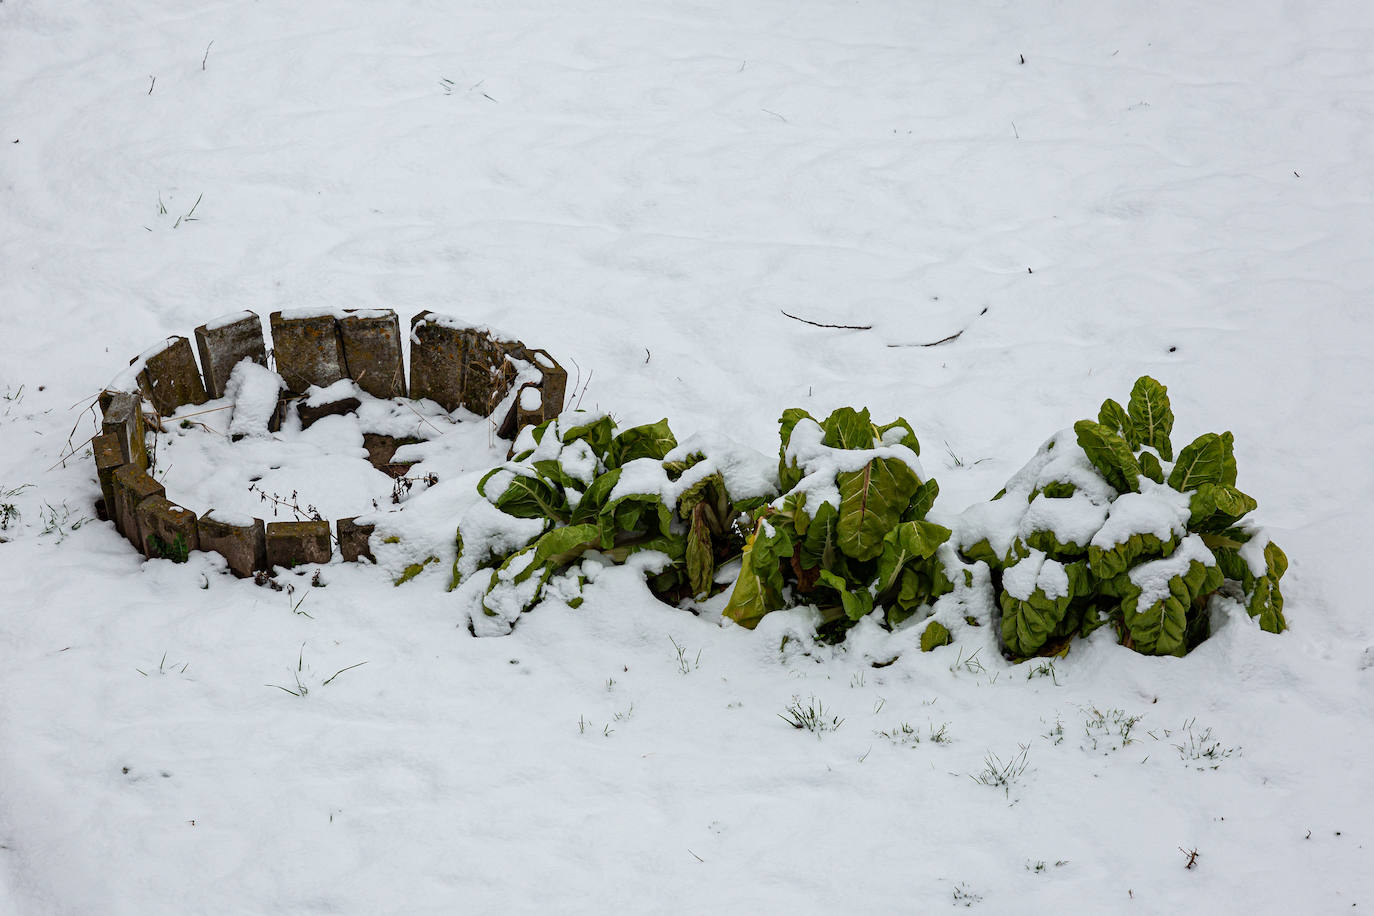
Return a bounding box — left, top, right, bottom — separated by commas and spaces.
92, 309, 567, 577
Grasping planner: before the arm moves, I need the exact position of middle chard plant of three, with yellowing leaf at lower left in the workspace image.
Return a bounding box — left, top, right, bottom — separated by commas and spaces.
724, 408, 958, 639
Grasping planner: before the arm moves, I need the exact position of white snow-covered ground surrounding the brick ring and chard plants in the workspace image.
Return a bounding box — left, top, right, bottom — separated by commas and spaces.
0, 0, 1374, 913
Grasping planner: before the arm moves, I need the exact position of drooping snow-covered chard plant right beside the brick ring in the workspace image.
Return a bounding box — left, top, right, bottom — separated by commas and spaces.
452, 412, 765, 623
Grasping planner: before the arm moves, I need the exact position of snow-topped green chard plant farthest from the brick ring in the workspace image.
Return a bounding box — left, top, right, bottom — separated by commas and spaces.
960, 376, 1287, 658
